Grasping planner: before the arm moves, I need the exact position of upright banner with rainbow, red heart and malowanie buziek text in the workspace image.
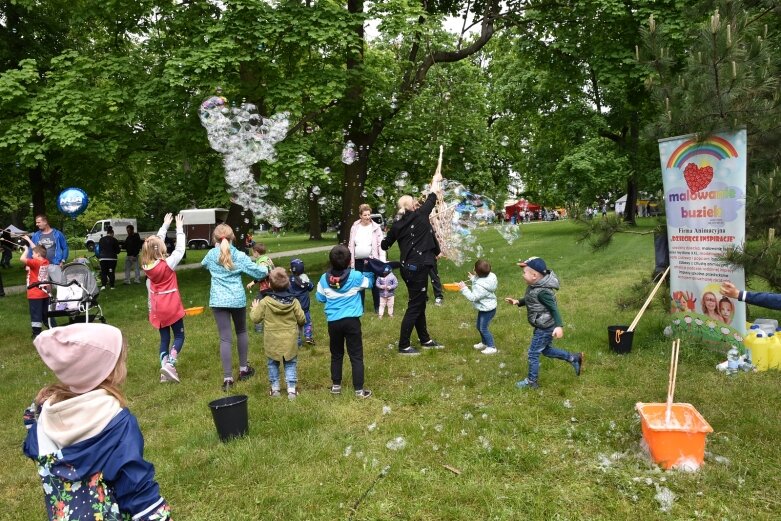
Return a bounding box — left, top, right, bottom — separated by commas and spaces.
659, 129, 746, 344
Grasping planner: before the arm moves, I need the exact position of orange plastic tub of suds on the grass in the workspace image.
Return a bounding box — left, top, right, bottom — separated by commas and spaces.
635, 403, 713, 469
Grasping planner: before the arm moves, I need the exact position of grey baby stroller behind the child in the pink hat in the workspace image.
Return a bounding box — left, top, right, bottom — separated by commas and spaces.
40, 262, 106, 327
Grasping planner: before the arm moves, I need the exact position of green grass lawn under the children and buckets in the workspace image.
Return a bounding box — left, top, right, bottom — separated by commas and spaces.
0, 222, 781, 521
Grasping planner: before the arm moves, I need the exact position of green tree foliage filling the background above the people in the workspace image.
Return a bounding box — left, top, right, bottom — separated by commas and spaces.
0, 0, 781, 278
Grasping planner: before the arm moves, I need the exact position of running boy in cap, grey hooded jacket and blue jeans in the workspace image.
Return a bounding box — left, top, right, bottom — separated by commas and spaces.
504, 257, 583, 389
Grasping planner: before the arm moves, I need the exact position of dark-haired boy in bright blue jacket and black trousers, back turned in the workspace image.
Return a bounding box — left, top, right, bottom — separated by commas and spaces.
315, 244, 372, 398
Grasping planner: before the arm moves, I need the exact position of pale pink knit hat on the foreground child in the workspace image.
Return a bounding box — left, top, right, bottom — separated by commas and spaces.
33, 324, 122, 393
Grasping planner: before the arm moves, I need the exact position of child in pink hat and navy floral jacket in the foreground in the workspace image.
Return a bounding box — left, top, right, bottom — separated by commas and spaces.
24, 324, 171, 521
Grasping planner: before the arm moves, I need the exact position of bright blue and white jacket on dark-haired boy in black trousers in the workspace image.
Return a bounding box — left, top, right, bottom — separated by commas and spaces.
315, 268, 369, 322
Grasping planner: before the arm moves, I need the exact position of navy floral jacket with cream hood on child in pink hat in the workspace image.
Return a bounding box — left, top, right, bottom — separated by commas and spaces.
23, 389, 170, 521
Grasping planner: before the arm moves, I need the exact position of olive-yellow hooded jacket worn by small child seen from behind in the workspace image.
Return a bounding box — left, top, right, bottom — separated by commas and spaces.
249, 291, 306, 362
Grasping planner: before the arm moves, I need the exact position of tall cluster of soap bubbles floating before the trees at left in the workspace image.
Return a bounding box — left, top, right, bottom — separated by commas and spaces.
198, 95, 289, 215
